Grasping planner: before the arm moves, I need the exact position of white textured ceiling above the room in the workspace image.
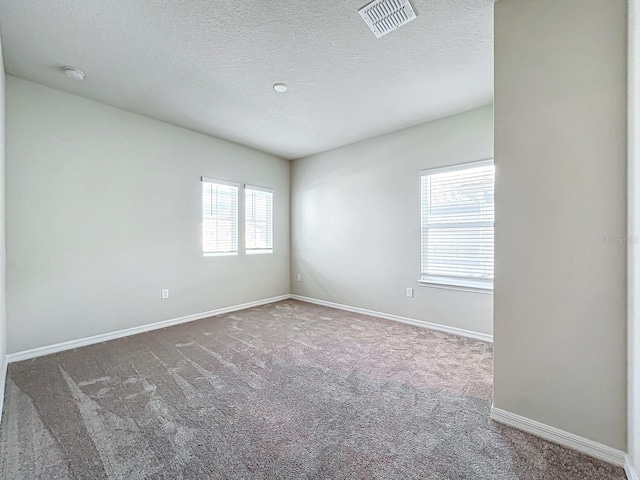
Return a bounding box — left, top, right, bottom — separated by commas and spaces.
0, 0, 493, 159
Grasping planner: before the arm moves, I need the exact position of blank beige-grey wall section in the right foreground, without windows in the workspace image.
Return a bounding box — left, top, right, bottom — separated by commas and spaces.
494, 0, 627, 451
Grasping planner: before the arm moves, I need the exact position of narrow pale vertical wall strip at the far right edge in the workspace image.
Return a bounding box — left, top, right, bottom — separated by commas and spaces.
627, 0, 640, 474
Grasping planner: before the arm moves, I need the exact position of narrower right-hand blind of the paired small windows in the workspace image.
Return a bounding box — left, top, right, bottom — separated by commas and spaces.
244, 185, 273, 254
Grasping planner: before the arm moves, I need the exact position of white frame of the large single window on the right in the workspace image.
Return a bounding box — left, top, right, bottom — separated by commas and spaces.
418, 158, 495, 294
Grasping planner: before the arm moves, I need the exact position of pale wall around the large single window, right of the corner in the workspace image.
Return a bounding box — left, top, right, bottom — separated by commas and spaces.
291, 106, 493, 334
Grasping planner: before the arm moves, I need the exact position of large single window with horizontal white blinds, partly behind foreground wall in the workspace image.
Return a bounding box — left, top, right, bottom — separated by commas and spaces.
421, 160, 494, 290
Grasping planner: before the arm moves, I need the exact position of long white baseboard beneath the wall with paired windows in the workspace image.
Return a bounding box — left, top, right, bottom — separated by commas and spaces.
7, 295, 291, 363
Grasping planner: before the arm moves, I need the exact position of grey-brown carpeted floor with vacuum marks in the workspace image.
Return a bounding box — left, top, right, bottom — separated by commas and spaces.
0, 300, 625, 480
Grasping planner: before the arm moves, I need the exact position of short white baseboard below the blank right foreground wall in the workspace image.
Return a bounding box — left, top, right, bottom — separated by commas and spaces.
491, 407, 625, 467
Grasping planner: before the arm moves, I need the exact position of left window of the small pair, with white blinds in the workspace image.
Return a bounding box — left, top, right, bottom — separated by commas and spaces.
202, 177, 238, 256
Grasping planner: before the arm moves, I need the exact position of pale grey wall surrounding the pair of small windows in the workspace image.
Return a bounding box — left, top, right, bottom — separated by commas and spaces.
7, 76, 290, 353
